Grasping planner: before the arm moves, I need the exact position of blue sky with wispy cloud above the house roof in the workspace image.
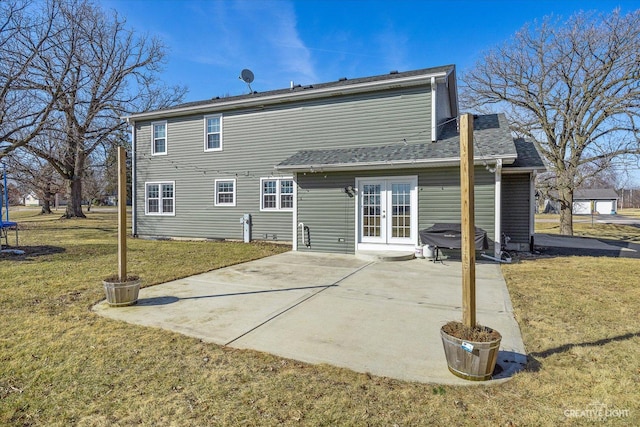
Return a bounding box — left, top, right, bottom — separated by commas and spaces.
100, 0, 640, 101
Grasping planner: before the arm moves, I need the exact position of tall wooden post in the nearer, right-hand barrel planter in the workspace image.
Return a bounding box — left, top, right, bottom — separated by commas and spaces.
460, 114, 476, 327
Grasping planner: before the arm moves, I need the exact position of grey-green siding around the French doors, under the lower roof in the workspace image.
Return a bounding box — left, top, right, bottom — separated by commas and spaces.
296, 168, 495, 253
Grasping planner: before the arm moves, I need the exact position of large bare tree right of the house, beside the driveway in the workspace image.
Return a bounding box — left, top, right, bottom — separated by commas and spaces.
462, 10, 640, 235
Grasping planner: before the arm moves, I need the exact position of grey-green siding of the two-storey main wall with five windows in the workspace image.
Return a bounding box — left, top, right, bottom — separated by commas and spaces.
135, 86, 431, 241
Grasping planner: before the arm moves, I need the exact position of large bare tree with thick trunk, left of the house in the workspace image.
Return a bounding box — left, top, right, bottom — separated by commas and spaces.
24, 0, 185, 217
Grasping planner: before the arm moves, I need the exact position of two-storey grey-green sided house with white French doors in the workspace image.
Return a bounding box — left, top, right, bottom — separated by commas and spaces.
126, 65, 545, 253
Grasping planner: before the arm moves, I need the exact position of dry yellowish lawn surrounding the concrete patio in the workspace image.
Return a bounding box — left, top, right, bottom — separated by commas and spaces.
0, 208, 640, 426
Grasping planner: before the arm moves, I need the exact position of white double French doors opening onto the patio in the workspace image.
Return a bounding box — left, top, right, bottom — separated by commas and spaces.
357, 177, 418, 250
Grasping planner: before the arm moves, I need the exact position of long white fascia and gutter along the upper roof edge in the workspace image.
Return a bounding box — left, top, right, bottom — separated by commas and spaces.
123, 71, 447, 120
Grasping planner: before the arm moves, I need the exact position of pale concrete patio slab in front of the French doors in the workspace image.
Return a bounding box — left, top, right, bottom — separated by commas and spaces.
94, 252, 526, 385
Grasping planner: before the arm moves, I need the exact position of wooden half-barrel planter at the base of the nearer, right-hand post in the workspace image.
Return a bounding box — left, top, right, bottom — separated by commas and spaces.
440, 326, 502, 381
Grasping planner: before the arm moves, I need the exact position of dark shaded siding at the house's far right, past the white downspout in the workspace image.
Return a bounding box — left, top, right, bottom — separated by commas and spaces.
502, 174, 531, 243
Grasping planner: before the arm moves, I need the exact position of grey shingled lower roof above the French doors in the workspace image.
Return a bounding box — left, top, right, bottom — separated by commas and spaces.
276, 114, 518, 169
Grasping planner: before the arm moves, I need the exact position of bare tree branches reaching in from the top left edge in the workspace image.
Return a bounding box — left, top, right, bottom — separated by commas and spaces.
0, 0, 68, 159
